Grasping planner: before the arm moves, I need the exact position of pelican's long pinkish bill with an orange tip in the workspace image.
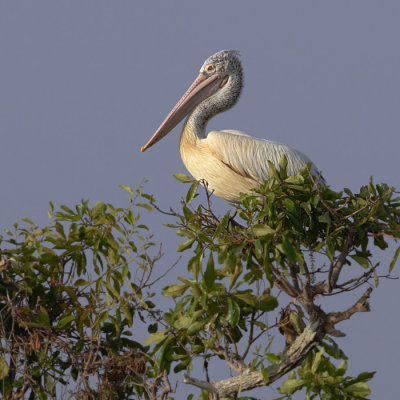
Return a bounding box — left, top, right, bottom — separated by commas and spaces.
141, 74, 223, 152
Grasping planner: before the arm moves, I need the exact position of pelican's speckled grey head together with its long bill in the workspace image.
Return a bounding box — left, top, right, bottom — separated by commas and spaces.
141, 50, 242, 152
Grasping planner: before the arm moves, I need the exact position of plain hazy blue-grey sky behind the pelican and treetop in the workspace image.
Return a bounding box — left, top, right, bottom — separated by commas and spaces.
0, 0, 400, 400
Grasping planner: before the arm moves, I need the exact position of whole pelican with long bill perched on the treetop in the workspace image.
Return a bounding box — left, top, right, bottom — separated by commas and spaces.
141, 50, 323, 202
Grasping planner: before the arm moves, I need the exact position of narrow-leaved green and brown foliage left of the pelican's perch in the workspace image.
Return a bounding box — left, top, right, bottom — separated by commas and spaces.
0, 187, 166, 399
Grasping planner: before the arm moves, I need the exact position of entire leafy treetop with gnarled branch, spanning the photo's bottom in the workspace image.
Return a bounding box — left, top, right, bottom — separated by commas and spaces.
0, 159, 400, 399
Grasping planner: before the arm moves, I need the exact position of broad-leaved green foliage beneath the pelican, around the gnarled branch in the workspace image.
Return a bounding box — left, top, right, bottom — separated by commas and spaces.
147, 159, 400, 399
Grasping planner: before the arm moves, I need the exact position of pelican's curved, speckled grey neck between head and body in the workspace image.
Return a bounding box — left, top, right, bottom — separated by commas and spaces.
181, 67, 243, 141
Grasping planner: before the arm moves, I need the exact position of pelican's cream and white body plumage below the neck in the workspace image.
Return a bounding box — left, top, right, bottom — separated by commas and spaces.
180, 126, 323, 201
